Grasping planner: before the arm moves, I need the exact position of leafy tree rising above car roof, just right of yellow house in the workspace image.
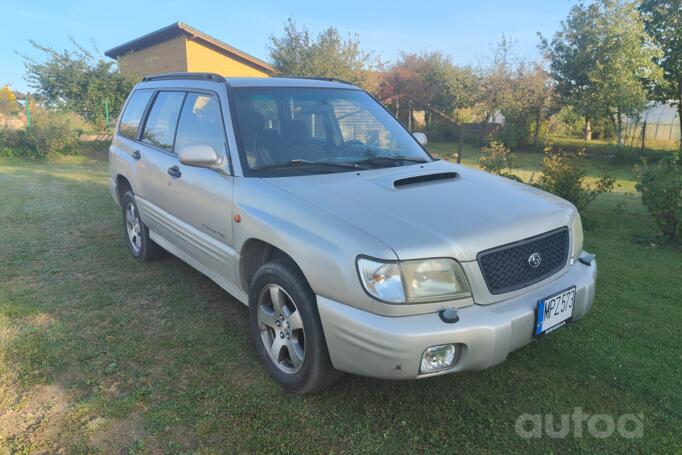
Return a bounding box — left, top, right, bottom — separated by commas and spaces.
268, 18, 379, 86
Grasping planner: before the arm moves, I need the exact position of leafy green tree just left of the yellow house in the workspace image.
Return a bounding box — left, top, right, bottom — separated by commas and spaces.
24, 41, 133, 129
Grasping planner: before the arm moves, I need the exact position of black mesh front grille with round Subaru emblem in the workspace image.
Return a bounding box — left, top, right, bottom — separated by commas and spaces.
477, 228, 569, 294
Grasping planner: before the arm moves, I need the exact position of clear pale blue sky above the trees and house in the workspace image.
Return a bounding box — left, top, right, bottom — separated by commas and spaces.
0, 0, 576, 90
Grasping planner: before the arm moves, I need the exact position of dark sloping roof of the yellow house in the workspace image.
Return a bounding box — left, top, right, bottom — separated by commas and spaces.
104, 22, 275, 73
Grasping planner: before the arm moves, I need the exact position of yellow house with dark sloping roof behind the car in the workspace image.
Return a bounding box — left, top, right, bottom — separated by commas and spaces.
104, 22, 274, 78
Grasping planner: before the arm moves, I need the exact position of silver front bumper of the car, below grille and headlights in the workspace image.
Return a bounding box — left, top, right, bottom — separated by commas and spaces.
317, 255, 597, 379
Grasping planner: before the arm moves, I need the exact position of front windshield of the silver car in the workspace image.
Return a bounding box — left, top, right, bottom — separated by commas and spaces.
232, 87, 431, 177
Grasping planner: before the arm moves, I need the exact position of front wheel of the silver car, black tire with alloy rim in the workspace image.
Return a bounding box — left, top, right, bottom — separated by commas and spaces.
249, 259, 340, 394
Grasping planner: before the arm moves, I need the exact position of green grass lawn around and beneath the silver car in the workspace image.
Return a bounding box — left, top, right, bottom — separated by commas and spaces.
0, 144, 682, 454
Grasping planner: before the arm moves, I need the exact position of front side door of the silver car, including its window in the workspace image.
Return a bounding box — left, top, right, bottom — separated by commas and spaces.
163, 92, 236, 282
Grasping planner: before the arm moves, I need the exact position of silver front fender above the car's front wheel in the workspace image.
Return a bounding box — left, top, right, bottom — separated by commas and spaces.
234, 178, 397, 311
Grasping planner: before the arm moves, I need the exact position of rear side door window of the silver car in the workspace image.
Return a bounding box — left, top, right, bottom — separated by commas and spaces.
142, 92, 185, 152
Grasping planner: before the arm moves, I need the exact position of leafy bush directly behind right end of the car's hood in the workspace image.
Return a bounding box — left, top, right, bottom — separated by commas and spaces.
537, 144, 616, 211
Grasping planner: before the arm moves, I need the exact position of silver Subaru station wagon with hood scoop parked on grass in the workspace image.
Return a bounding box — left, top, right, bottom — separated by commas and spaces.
109, 73, 597, 393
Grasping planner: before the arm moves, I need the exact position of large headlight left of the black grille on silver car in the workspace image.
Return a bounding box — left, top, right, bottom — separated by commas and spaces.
358, 257, 471, 303
